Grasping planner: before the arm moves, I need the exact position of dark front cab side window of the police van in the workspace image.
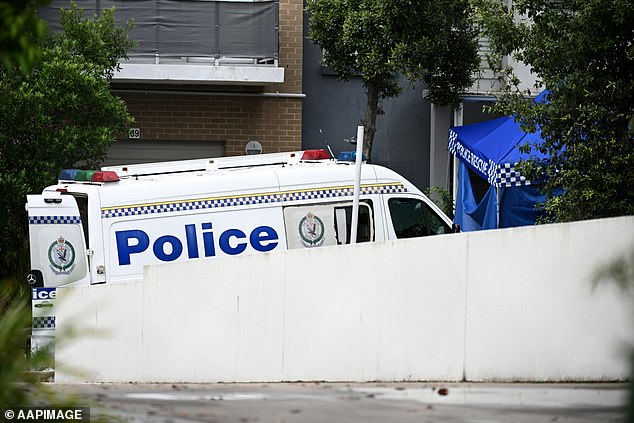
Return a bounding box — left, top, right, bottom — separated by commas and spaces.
388, 198, 451, 238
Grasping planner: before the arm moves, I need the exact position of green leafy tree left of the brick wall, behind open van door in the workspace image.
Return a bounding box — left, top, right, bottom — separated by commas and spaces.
0, 5, 132, 279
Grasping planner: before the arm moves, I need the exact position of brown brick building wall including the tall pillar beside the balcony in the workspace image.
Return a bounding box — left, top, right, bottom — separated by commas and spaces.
113, 0, 303, 155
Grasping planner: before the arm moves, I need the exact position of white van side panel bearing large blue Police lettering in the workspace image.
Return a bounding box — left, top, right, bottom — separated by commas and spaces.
106, 207, 286, 281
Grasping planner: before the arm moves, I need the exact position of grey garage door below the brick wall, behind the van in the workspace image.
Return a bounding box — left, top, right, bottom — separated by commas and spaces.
102, 140, 225, 166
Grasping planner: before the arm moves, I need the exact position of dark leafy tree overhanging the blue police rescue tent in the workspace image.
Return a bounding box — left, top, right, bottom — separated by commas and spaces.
476, 0, 634, 221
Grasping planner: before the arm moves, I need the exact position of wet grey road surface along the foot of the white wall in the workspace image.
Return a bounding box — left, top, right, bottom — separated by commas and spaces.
50, 383, 629, 423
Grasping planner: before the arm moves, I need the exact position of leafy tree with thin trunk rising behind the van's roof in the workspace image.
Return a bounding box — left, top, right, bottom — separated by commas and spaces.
306, 0, 479, 159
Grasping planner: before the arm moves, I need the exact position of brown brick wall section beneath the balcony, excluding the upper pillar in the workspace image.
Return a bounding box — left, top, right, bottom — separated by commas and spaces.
119, 91, 302, 155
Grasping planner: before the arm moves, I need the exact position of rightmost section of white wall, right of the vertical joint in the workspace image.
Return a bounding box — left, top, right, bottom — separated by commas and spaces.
465, 217, 634, 381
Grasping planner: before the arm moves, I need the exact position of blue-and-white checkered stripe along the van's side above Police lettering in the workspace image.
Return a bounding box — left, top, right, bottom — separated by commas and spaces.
101, 183, 407, 219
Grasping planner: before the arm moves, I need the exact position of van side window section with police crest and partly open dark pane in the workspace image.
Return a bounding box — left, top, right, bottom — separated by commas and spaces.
284, 201, 374, 249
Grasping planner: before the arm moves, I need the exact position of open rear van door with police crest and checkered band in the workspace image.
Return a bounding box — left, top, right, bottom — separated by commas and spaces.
27, 192, 88, 287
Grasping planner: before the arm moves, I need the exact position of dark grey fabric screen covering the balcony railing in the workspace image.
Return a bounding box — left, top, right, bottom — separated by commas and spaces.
38, 0, 279, 59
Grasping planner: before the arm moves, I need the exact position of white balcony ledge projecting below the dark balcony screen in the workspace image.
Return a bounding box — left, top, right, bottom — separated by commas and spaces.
112, 63, 284, 85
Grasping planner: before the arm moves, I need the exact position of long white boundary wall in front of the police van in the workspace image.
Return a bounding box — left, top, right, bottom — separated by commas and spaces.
56, 217, 634, 382
